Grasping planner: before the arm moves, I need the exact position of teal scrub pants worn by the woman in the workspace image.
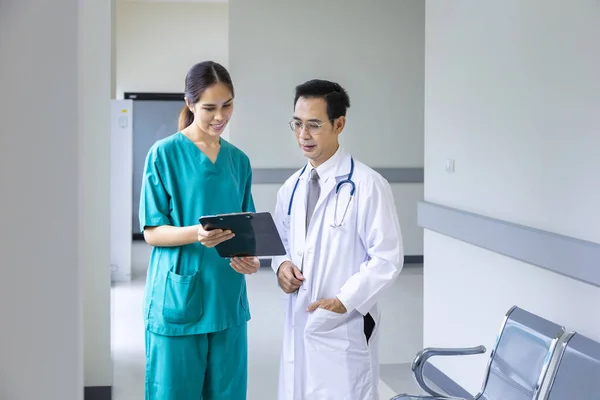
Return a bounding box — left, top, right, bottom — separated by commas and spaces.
145, 323, 248, 400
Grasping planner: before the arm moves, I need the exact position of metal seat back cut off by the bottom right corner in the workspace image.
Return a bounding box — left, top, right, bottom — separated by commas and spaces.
544, 332, 600, 400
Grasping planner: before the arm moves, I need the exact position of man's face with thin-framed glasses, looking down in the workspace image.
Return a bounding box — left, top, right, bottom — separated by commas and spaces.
292, 97, 346, 167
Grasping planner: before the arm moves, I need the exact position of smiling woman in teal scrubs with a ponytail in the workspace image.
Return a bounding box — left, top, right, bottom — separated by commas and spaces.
139, 61, 260, 400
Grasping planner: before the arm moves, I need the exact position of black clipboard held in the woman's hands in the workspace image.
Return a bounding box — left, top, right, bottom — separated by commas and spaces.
199, 212, 286, 258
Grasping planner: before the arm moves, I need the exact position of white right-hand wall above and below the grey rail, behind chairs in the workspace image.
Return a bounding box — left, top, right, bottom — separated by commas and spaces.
424, 0, 600, 391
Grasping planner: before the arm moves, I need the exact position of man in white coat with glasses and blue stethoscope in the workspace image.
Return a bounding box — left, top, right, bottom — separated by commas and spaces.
272, 80, 404, 400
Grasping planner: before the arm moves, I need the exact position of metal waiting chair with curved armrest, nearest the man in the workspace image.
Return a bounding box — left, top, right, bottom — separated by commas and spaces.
391, 306, 565, 400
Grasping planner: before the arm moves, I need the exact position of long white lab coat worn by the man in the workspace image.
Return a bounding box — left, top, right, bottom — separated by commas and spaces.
272, 149, 404, 400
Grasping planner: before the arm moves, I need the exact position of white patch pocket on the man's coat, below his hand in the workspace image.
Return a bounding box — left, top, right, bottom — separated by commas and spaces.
306, 308, 350, 352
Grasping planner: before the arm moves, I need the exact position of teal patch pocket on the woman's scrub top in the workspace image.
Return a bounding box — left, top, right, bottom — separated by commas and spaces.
163, 271, 203, 324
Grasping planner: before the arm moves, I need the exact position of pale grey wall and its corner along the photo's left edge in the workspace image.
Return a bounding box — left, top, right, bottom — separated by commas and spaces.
0, 0, 110, 400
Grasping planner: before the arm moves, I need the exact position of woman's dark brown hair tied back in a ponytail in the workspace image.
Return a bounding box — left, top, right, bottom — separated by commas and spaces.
178, 61, 234, 130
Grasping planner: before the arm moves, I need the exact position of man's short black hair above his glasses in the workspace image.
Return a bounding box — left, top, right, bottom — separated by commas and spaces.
294, 79, 350, 121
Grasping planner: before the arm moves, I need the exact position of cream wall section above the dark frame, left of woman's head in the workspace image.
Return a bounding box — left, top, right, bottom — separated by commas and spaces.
116, 0, 229, 98
